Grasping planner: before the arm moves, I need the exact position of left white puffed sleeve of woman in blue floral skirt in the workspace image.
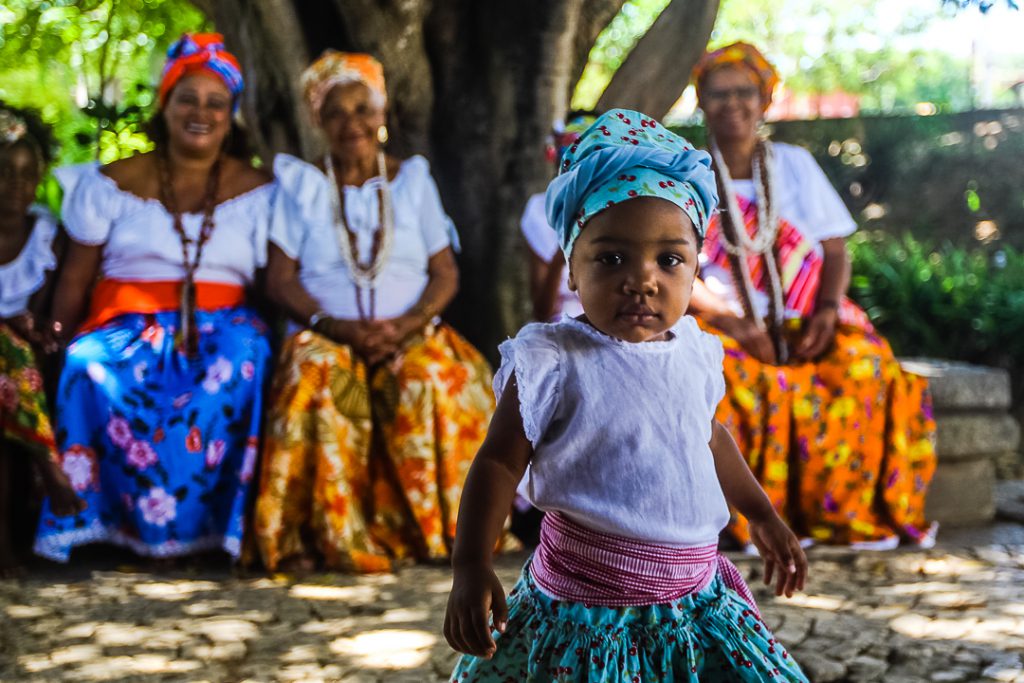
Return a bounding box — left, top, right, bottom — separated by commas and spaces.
53, 163, 126, 246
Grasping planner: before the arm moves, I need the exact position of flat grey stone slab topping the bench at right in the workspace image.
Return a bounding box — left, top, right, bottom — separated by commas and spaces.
900, 358, 1012, 413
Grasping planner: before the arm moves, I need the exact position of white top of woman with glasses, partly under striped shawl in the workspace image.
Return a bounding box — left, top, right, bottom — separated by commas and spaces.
700, 142, 857, 317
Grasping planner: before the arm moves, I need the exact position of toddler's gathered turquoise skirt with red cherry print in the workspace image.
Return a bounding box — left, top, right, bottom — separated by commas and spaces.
451, 564, 807, 683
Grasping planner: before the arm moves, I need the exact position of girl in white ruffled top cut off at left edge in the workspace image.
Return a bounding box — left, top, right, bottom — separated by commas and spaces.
0, 102, 79, 577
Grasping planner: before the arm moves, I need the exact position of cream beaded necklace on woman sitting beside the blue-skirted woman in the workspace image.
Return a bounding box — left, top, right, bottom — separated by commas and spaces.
324, 151, 394, 321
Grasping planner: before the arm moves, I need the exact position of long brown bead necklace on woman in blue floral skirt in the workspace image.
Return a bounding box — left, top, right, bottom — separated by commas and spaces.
157, 154, 222, 355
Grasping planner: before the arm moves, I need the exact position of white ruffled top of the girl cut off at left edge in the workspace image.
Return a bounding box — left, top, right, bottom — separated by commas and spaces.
0, 206, 57, 317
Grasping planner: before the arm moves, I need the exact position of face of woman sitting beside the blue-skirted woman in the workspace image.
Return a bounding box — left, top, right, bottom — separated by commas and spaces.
321, 83, 386, 159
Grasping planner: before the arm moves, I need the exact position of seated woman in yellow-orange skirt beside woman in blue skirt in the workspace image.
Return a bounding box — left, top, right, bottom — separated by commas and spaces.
256, 51, 495, 571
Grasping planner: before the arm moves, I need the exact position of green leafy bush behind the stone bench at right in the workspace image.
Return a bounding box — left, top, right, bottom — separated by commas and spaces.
849, 232, 1024, 371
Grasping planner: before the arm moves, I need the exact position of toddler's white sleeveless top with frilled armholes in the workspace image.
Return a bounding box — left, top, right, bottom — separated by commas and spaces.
495, 315, 729, 546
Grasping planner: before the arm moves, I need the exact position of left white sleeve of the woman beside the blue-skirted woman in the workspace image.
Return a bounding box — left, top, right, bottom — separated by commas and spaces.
269, 155, 331, 260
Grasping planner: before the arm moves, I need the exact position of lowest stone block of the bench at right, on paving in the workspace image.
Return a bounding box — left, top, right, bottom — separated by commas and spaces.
925, 458, 995, 526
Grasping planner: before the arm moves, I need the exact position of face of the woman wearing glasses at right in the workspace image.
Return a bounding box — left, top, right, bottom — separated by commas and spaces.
700, 67, 764, 140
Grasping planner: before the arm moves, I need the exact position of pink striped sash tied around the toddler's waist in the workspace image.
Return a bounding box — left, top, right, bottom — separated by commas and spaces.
530, 512, 757, 611
